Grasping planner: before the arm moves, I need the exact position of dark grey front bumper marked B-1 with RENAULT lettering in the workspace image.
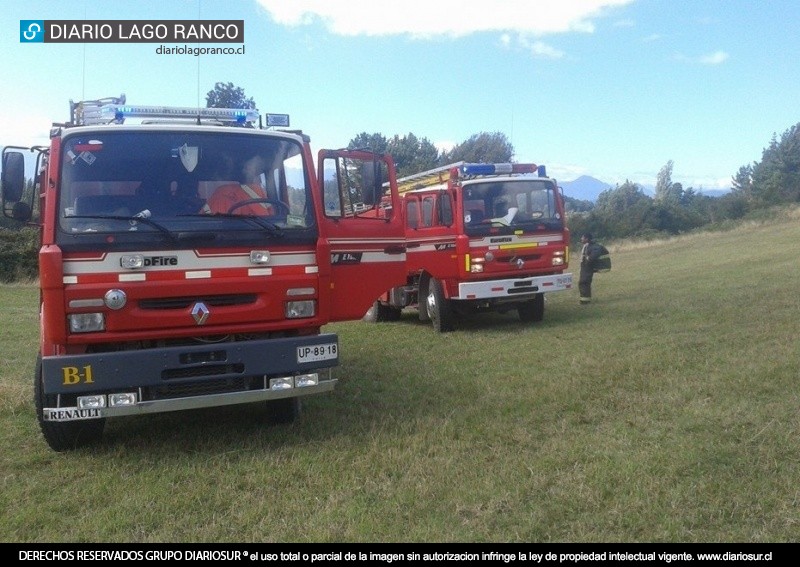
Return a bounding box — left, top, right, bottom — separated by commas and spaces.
42, 334, 339, 421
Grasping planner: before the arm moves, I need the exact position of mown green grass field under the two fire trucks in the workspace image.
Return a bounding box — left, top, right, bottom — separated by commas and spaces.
0, 212, 800, 542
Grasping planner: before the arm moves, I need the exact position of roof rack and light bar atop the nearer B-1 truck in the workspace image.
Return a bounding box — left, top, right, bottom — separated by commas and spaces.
69, 94, 260, 126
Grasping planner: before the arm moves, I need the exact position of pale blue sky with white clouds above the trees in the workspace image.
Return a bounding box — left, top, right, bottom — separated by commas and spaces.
0, 0, 800, 191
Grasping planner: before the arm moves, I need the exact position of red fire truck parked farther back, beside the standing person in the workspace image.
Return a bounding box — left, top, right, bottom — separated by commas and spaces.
364, 162, 572, 332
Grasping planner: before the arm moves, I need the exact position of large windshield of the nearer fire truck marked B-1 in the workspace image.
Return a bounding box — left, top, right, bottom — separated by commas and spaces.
58, 130, 315, 248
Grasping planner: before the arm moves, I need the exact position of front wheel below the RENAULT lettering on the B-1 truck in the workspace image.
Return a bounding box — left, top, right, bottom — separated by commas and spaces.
33, 355, 106, 452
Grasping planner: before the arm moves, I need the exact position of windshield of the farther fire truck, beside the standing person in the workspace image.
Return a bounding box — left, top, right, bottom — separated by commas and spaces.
462, 178, 563, 234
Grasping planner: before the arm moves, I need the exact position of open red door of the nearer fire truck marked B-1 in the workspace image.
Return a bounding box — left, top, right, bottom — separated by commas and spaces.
317, 150, 406, 321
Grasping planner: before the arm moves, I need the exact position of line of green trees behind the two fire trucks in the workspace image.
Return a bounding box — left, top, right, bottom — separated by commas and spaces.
0, 83, 800, 281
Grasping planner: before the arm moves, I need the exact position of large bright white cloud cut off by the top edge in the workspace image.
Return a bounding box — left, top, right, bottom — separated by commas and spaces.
257, 0, 634, 37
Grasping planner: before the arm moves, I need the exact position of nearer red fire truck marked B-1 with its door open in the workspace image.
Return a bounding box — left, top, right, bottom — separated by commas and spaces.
2, 95, 405, 451
